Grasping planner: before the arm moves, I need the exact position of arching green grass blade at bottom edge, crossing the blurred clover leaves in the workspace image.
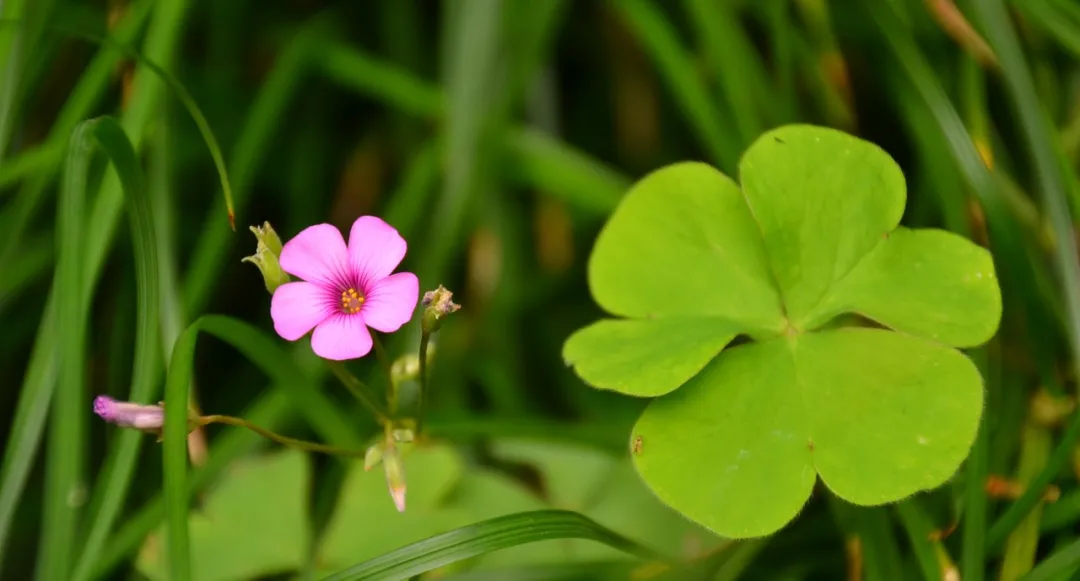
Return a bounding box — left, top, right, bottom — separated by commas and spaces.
323, 511, 663, 581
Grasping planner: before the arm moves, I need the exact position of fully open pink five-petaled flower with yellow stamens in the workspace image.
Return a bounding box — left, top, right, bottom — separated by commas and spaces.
270, 216, 420, 361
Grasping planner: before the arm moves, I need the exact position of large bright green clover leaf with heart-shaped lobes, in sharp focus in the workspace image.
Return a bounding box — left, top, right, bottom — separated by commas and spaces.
564, 125, 1001, 538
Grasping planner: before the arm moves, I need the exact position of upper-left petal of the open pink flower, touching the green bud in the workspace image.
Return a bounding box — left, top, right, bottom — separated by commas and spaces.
278, 224, 348, 285
